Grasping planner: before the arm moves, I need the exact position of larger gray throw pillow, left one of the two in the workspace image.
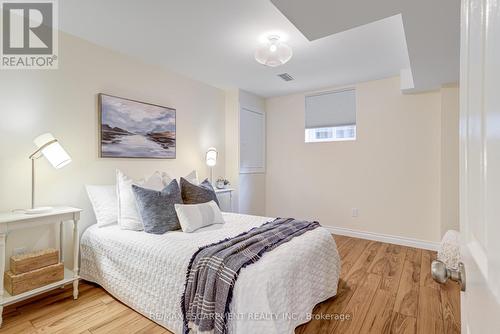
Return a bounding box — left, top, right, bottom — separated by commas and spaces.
132, 180, 182, 234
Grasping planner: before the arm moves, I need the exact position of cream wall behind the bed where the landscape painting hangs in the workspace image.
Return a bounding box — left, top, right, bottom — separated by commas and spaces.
0, 33, 225, 268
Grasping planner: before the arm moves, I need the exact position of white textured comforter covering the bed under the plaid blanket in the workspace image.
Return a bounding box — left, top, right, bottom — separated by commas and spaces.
80, 213, 340, 334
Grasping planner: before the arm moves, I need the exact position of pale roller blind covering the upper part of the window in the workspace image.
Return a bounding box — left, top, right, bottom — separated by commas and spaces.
306, 89, 356, 129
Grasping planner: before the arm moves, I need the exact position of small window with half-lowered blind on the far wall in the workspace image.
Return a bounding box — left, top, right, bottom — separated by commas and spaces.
305, 89, 356, 143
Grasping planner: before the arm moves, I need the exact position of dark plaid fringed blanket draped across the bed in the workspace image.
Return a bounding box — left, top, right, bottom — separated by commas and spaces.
181, 218, 319, 333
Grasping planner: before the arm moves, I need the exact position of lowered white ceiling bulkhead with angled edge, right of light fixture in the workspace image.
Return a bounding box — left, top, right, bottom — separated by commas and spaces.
271, 0, 460, 91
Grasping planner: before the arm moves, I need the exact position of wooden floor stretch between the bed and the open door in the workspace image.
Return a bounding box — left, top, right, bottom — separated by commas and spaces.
295, 236, 460, 334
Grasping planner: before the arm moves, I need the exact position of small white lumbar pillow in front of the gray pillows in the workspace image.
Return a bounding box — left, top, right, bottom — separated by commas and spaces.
174, 201, 224, 233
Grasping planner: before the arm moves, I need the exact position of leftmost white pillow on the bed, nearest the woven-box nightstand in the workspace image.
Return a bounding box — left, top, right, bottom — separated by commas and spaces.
85, 185, 118, 227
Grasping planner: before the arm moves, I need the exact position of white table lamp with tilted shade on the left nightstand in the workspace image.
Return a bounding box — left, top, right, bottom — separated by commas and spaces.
26, 133, 71, 214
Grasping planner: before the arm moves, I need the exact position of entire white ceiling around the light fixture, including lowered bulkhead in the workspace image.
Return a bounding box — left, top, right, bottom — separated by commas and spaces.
59, 0, 459, 97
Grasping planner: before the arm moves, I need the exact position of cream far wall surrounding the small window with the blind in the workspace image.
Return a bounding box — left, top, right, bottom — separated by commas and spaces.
266, 77, 458, 241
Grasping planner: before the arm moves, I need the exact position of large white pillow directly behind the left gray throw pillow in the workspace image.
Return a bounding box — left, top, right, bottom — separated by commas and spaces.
116, 170, 165, 231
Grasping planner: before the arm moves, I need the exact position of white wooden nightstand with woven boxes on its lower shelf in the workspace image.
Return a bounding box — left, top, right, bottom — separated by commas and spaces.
0, 207, 82, 326
